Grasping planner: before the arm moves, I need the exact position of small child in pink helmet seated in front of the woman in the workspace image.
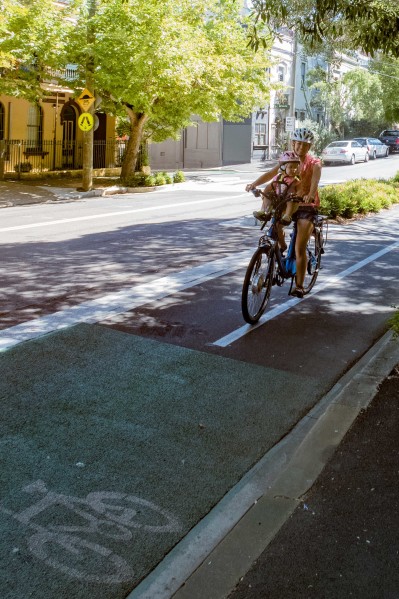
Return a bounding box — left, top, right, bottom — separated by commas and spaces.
253, 151, 301, 225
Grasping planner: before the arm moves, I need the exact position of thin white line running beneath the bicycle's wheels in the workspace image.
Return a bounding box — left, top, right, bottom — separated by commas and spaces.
212, 241, 399, 347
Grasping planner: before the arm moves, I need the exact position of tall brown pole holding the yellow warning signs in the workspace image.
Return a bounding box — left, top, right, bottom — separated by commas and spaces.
82, 0, 96, 191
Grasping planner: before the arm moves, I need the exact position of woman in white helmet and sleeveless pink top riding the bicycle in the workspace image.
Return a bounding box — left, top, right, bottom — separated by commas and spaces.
246, 127, 321, 297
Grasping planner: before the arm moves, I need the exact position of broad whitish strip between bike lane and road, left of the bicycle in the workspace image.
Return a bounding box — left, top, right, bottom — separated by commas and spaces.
0, 249, 253, 351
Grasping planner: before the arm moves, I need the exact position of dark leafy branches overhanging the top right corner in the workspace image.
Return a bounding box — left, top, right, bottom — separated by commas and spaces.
250, 0, 399, 57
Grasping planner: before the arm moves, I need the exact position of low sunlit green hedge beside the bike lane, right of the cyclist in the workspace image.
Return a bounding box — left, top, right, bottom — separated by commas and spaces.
319, 178, 399, 218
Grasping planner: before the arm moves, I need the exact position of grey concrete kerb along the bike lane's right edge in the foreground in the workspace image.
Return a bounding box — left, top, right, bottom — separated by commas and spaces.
127, 332, 399, 599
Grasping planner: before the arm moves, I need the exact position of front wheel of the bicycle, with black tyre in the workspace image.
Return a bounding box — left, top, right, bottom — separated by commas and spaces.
241, 247, 275, 324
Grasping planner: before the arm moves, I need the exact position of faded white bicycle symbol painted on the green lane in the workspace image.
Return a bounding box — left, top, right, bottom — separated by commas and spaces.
0, 480, 181, 584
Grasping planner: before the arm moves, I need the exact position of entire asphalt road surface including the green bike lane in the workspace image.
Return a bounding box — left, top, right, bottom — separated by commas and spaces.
0, 158, 399, 599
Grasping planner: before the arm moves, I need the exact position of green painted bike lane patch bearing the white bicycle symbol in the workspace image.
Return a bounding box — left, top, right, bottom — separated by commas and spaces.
0, 324, 317, 599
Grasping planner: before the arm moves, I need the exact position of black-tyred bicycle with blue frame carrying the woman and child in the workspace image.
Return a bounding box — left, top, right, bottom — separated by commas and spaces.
241, 189, 327, 324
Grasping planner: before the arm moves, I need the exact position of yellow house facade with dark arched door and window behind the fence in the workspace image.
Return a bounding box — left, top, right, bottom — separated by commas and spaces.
0, 65, 117, 173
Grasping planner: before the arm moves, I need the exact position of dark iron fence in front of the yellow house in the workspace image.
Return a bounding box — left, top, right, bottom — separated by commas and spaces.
3, 139, 127, 174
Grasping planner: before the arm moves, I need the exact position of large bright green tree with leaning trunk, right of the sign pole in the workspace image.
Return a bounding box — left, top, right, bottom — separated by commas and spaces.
70, 0, 276, 178
